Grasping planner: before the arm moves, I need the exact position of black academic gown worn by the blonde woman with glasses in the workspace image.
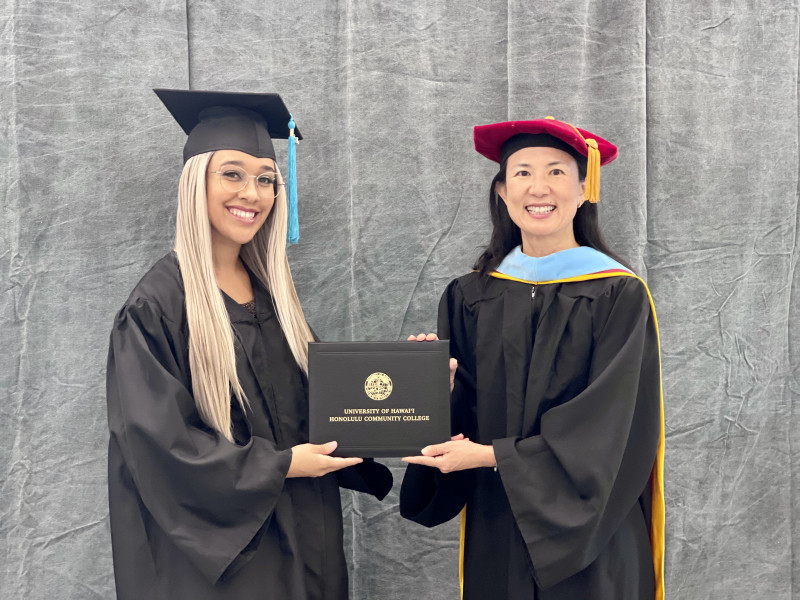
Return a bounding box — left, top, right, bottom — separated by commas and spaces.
107, 254, 392, 600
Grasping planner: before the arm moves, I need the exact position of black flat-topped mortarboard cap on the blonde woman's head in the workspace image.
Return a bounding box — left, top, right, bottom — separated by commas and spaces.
153, 89, 303, 162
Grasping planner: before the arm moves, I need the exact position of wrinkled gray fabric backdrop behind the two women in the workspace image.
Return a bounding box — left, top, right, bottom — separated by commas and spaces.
0, 0, 800, 600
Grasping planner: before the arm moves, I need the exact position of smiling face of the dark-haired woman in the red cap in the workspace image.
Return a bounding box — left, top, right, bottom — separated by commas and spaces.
495, 146, 586, 256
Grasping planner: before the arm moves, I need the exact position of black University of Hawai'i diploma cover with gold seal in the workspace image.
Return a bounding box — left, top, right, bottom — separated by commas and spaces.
308, 340, 450, 458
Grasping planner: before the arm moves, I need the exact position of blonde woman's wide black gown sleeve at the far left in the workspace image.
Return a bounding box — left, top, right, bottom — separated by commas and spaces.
107, 299, 291, 583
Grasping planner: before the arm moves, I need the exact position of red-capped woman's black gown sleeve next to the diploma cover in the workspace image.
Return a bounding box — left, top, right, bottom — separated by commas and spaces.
400, 281, 476, 527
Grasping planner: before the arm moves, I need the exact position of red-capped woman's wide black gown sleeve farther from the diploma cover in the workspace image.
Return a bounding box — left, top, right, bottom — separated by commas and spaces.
493, 278, 660, 588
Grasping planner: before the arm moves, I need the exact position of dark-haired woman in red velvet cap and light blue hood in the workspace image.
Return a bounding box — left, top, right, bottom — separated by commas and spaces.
400, 118, 664, 600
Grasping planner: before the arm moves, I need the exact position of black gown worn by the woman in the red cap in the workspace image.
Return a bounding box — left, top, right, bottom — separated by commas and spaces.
400, 273, 661, 600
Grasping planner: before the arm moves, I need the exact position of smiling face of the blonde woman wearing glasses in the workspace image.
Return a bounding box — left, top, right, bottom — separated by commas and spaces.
206, 150, 276, 254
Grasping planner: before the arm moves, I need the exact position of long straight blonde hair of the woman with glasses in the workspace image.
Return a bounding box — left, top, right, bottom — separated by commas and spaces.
175, 152, 313, 441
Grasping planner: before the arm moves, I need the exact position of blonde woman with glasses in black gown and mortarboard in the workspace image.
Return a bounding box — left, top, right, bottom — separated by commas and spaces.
107, 90, 392, 600
